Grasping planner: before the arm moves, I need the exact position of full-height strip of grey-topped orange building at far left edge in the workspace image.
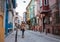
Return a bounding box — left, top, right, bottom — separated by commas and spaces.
0, 0, 5, 42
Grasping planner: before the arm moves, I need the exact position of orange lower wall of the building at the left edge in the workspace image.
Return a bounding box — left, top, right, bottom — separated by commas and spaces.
0, 11, 4, 42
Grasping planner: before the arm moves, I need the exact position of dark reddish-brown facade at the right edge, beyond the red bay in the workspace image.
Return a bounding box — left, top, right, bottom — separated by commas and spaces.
49, 0, 60, 35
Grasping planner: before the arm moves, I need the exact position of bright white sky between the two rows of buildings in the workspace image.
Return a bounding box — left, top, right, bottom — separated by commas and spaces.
16, 0, 30, 17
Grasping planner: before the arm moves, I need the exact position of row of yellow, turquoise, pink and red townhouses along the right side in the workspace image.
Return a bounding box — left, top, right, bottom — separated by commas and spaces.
26, 0, 60, 35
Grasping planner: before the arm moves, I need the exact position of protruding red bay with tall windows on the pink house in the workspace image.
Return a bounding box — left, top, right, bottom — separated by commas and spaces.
40, 0, 49, 14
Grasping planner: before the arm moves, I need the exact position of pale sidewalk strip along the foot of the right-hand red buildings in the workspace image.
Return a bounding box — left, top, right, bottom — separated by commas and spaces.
30, 31, 60, 42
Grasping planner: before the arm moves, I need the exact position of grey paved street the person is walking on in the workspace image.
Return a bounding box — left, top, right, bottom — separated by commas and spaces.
5, 31, 59, 42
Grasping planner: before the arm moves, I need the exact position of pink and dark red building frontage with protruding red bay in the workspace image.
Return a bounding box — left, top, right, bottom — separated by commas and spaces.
36, 0, 60, 34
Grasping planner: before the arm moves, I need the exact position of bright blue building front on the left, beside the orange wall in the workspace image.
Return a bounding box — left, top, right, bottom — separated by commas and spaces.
5, 0, 16, 35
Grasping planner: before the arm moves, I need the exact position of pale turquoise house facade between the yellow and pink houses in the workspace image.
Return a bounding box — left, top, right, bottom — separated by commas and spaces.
29, 0, 35, 26
